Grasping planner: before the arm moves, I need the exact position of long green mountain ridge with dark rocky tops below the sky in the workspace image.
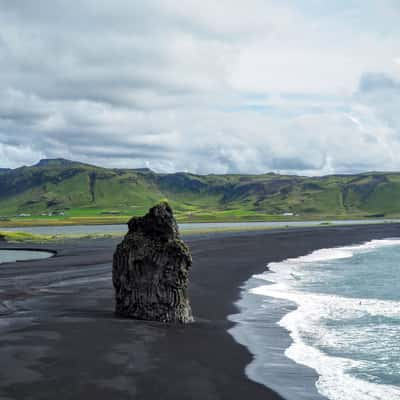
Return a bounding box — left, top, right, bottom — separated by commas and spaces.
0, 159, 400, 221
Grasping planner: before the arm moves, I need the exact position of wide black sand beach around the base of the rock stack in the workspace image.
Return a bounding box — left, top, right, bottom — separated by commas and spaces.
0, 224, 400, 400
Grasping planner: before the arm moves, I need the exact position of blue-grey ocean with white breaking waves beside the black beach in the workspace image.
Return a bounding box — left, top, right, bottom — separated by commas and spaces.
231, 239, 400, 400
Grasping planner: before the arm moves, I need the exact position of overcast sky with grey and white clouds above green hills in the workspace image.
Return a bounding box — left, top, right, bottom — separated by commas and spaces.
0, 0, 400, 175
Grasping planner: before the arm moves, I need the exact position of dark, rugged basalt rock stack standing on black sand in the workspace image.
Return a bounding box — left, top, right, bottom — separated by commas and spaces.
113, 202, 193, 323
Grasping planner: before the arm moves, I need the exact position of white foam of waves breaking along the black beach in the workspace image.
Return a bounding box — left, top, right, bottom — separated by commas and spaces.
251, 239, 400, 400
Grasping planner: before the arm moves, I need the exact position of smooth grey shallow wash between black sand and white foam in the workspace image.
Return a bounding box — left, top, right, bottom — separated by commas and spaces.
229, 278, 327, 400
